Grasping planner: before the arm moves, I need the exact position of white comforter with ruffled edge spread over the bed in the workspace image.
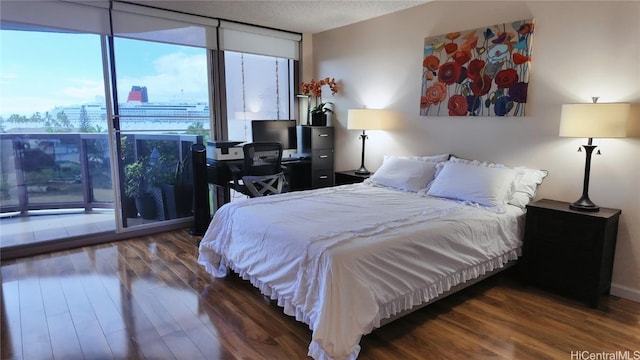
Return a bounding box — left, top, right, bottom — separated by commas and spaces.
199, 184, 523, 359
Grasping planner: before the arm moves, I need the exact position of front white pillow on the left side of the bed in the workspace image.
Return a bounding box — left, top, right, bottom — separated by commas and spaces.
366, 156, 436, 192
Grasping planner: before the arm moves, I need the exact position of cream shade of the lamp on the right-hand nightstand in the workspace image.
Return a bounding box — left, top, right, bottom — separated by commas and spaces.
560, 103, 631, 138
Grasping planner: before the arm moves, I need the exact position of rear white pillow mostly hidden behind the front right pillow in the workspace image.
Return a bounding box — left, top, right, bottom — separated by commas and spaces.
448, 156, 548, 209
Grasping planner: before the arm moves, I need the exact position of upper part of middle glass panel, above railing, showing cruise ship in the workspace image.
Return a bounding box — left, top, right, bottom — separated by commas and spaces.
114, 38, 211, 137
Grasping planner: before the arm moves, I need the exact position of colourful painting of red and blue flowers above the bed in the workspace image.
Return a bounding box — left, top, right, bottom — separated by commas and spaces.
420, 19, 534, 116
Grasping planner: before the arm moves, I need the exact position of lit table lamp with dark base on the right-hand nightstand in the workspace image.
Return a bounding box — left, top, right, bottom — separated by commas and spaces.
560, 97, 631, 211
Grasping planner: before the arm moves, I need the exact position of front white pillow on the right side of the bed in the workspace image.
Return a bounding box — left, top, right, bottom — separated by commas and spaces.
427, 162, 516, 210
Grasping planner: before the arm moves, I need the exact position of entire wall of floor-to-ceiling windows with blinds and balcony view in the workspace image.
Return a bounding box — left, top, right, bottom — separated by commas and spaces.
0, 1, 300, 258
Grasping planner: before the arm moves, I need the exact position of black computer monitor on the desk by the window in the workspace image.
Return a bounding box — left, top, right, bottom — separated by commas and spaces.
251, 120, 298, 159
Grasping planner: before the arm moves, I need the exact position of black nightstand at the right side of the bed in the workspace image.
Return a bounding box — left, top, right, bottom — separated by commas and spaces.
520, 199, 621, 307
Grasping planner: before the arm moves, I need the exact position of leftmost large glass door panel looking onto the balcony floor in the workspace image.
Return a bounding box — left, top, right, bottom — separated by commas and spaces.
0, 28, 115, 247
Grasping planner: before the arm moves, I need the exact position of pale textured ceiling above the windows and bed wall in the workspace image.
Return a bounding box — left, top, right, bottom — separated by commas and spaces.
127, 0, 430, 34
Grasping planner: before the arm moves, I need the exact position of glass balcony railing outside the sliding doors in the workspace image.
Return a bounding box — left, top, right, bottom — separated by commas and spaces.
0, 133, 202, 220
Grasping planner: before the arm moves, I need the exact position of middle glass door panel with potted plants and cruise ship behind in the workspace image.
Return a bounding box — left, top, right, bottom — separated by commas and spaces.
113, 38, 211, 227
